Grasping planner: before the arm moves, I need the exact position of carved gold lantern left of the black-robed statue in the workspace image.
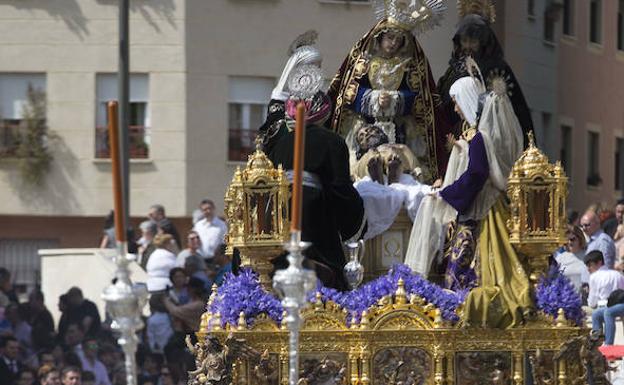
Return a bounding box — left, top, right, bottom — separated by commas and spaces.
225, 141, 290, 289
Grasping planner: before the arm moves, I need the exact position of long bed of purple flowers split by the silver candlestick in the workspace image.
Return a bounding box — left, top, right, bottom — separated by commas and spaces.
208, 265, 467, 326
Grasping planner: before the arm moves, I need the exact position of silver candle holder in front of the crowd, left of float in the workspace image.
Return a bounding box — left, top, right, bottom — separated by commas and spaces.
102, 242, 148, 385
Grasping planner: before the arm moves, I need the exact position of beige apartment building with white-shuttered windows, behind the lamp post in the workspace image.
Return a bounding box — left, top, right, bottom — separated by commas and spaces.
0, 0, 457, 284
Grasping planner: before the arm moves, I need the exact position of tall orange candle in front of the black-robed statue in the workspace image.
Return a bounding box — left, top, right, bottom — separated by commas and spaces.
290, 103, 305, 232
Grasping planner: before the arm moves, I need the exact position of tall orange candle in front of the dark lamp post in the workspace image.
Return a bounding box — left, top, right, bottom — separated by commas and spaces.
108, 101, 126, 242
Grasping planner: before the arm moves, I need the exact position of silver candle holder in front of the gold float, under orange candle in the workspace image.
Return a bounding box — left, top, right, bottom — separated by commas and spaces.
273, 231, 316, 385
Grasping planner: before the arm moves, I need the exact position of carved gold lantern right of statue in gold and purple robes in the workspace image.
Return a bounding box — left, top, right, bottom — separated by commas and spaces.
507, 134, 568, 283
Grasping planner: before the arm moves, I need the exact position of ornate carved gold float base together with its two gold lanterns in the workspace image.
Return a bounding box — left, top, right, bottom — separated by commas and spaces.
189, 141, 606, 385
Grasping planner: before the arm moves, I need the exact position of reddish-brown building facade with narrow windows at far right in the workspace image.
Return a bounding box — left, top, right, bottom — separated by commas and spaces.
556, 0, 624, 211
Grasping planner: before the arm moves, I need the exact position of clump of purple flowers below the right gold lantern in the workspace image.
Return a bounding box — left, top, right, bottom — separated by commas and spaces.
535, 266, 585, 326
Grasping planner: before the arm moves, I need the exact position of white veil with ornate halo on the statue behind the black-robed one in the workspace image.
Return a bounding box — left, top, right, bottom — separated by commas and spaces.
271, 30, 323, 101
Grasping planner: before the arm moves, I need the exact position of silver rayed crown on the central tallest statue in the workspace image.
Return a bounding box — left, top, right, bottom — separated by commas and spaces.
373, 0, 446, 35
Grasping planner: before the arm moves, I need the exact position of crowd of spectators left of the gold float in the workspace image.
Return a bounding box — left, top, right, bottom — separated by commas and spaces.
0, 199, 231, 385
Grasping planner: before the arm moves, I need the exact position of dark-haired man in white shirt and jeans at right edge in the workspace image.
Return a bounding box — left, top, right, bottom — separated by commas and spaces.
585, 250, 624, 345
